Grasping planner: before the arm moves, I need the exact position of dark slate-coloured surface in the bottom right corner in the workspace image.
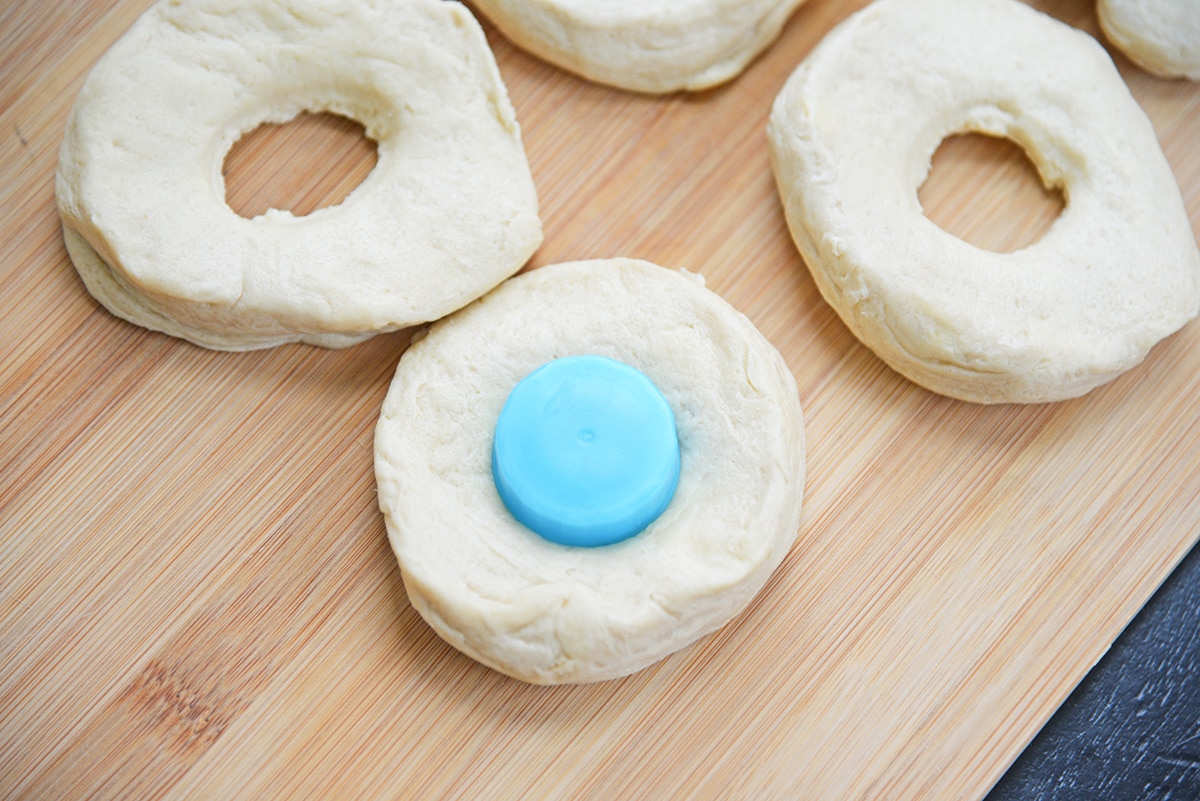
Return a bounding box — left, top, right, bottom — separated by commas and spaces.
986, 537, 1200, 801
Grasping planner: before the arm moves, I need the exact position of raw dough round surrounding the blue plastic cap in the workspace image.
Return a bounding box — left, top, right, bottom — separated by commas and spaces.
376, 259, 804, 683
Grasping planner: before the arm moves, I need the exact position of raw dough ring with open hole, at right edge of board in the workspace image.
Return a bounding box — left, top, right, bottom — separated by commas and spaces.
768, 0, 1200, 403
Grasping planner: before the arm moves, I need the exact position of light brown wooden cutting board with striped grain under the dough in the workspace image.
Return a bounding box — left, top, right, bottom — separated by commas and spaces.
0, 0, 1200, 799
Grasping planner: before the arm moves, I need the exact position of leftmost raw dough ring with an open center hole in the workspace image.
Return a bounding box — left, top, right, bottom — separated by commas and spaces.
56, 0, 541, 350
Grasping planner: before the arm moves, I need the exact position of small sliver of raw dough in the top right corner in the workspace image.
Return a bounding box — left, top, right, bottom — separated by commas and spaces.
1096, 0, 1200, 80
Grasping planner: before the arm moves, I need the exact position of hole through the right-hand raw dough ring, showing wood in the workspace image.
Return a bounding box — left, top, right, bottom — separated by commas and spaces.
918, 133, 1067, 253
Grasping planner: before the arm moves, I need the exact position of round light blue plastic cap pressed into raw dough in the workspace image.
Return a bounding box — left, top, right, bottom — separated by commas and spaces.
492, 356, 679, 547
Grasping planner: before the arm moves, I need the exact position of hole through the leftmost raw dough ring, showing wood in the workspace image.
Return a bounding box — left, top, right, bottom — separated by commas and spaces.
222, 112, 378, 218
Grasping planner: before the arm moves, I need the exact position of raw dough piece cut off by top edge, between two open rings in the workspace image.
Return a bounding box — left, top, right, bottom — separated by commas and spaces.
465, 0, 804, 92
